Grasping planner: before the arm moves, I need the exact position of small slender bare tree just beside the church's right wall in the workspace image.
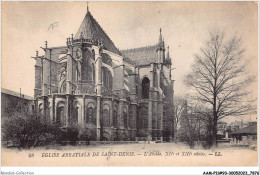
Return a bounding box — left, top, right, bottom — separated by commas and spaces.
173, 96, 185, 143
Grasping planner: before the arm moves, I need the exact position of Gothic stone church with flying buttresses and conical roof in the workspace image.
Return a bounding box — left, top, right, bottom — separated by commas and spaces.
34, 7, 173, 141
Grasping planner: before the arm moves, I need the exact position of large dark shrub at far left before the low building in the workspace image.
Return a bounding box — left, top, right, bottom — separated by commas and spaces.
2, 111, 55, 148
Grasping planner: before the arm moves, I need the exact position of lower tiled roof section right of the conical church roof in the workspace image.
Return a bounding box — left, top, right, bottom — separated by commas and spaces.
121, 45, 158, 65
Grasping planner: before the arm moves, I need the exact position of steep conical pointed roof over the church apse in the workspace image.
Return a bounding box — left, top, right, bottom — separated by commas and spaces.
74, 11, 121, 55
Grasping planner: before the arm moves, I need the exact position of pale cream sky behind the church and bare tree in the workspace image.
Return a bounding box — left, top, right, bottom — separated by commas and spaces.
1, 2, 258, 121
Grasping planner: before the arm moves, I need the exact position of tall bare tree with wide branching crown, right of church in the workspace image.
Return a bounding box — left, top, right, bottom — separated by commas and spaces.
186, 32, 255, 146
